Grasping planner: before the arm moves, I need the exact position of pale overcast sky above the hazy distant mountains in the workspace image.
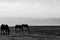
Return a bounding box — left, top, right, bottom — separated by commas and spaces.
0, 0, 60, 18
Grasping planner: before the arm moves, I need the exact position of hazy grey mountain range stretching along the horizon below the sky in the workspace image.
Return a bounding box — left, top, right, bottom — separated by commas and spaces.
0, 18, 60, 25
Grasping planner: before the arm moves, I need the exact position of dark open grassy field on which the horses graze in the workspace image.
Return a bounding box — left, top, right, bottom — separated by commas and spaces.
0, 26, 60, 40
